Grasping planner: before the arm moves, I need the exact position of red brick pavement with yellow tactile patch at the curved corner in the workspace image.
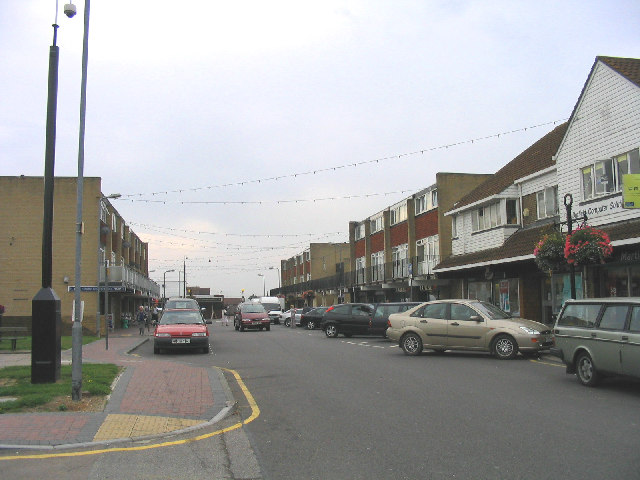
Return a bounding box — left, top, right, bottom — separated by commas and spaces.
0, 329, 234, 449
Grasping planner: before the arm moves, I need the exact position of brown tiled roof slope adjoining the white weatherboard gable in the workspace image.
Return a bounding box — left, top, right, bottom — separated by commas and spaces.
453, 122, 567, 209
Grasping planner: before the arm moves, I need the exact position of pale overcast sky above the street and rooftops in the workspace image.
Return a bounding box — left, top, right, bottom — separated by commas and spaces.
0, 0, 640, 296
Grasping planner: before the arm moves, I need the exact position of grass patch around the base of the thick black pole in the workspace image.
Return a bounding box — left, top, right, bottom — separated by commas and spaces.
0, 363, 121, 414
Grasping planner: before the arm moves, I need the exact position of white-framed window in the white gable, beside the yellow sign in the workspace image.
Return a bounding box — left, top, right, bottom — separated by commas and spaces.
581, 148, 640, 200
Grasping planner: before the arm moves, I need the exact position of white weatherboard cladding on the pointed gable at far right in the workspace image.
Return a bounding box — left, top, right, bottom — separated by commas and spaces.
556, 62, 640, 225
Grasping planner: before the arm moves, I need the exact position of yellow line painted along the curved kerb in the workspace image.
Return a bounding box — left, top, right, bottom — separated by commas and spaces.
0, 367, 255, 461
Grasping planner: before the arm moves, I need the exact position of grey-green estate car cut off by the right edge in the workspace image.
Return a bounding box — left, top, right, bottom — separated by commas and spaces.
551, 297, 640, 387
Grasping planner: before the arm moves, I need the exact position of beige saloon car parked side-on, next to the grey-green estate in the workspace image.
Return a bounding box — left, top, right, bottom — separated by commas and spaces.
387, 300, 553, 360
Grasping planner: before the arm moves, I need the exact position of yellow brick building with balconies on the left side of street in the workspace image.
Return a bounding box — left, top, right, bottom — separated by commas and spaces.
0, 176, 160, 334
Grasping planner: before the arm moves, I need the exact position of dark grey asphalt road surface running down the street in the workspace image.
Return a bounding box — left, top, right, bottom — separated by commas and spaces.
202, 326, 640, 480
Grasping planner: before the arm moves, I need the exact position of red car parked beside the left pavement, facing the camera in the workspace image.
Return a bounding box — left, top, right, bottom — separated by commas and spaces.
153, 309, 211, 353
